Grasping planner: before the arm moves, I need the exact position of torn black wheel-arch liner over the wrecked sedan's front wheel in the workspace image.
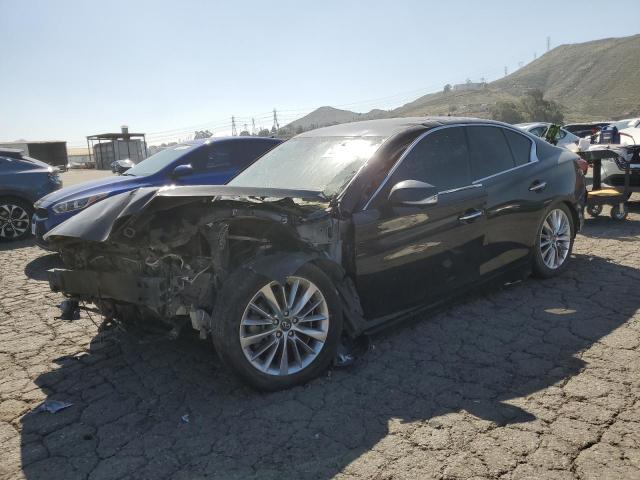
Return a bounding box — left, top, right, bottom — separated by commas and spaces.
244, 251, 366, 337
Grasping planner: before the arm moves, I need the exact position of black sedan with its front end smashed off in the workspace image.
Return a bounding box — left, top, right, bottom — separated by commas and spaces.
47, 118, 585, 390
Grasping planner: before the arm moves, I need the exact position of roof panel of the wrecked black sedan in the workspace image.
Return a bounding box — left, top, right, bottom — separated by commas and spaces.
297, 117, 511, 138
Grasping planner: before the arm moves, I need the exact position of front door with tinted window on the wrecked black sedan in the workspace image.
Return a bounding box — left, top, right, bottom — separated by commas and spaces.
353, 127, 485, 318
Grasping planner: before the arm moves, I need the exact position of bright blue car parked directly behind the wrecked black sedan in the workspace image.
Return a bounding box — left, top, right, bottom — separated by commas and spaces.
32, 137, 282, 249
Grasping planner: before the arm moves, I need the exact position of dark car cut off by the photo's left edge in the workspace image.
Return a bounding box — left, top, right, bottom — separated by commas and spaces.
0, 148, 62, 240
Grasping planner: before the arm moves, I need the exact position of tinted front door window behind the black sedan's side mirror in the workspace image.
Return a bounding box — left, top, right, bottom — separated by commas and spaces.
388, 127, 471, 192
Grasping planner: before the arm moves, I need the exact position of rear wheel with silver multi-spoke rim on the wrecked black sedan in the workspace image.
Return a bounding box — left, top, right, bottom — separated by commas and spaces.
533, 204, 575, 278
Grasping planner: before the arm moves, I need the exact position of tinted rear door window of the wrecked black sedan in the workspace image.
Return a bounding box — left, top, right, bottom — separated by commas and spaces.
466, 126, 515, 180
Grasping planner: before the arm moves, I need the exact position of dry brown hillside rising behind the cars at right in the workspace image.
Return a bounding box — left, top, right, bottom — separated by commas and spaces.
289, 35, 640, 130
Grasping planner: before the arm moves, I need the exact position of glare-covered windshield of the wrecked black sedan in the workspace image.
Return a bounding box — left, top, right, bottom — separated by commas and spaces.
229, 137, 384, 197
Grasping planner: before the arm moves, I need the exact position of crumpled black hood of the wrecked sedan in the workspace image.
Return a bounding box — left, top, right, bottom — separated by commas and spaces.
44, 185, 328, 242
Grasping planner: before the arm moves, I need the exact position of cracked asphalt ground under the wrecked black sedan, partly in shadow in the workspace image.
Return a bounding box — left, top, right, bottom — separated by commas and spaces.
0, 201, 640, 479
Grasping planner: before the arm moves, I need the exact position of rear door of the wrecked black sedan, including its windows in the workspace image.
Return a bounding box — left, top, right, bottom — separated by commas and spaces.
466, 125, 552, 276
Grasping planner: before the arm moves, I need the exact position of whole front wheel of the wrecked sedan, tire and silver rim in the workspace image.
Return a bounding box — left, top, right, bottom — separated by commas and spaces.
213, 264, 342, 390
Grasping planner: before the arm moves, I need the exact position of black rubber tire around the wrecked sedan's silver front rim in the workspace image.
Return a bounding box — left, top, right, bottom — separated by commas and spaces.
212, 264, 342, 391
